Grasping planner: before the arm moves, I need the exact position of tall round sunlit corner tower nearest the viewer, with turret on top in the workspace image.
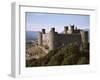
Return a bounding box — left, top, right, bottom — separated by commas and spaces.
49, 28, 55, 50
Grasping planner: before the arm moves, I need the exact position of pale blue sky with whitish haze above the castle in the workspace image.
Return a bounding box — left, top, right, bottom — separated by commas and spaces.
25, 12, 90, 32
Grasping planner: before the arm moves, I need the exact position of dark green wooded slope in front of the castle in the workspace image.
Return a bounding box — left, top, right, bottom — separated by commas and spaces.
26, 43, 89, 67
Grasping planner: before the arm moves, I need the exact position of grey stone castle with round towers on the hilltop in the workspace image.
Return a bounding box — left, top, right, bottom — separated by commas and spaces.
38, 25, 88, 50
